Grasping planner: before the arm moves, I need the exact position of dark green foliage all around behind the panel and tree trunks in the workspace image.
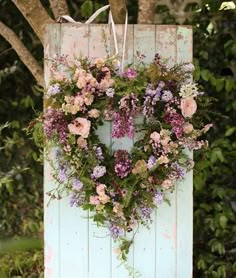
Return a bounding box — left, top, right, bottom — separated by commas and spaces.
0, 0, 236, 278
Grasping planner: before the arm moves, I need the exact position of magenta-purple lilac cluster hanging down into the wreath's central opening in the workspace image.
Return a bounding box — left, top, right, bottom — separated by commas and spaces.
112, 112, 134, 139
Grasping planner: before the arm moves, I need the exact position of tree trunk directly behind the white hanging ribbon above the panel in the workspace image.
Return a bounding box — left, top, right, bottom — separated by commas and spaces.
109, 0, 126, 24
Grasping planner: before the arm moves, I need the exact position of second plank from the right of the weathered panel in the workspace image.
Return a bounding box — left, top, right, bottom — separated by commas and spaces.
156, 25, 177, 278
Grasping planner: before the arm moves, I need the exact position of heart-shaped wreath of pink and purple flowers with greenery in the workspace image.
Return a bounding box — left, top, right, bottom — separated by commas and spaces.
39, 54, 211, 268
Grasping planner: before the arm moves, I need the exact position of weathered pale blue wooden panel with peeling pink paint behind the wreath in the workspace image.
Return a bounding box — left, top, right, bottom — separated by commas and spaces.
45, 24, 192, 278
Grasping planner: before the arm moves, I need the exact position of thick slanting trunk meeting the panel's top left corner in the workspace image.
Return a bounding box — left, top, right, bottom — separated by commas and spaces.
12, 0, 54, 44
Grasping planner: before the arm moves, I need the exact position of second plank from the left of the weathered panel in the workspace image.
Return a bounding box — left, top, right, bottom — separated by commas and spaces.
60, 24, 89, 278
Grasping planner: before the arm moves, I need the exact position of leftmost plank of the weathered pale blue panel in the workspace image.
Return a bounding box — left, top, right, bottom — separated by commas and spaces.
44, 24, 61, 278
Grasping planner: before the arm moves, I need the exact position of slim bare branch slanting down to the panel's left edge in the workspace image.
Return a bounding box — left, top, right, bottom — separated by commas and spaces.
0, 22, 44, 87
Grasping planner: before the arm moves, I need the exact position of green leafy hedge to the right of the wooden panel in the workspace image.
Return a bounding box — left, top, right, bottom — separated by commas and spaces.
193, 1, 236, 278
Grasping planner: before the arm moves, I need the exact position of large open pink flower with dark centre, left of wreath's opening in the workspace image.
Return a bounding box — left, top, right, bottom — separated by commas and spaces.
68, 118, 91, 138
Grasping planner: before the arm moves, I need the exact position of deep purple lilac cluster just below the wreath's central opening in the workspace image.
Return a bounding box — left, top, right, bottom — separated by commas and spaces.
114, 150, 131, 178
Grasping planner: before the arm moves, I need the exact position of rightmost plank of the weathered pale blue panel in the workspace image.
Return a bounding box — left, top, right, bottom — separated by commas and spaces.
176, 26, 193, 278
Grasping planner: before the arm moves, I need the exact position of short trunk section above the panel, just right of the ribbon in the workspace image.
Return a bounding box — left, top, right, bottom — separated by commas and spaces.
138, 0, 156, 24
